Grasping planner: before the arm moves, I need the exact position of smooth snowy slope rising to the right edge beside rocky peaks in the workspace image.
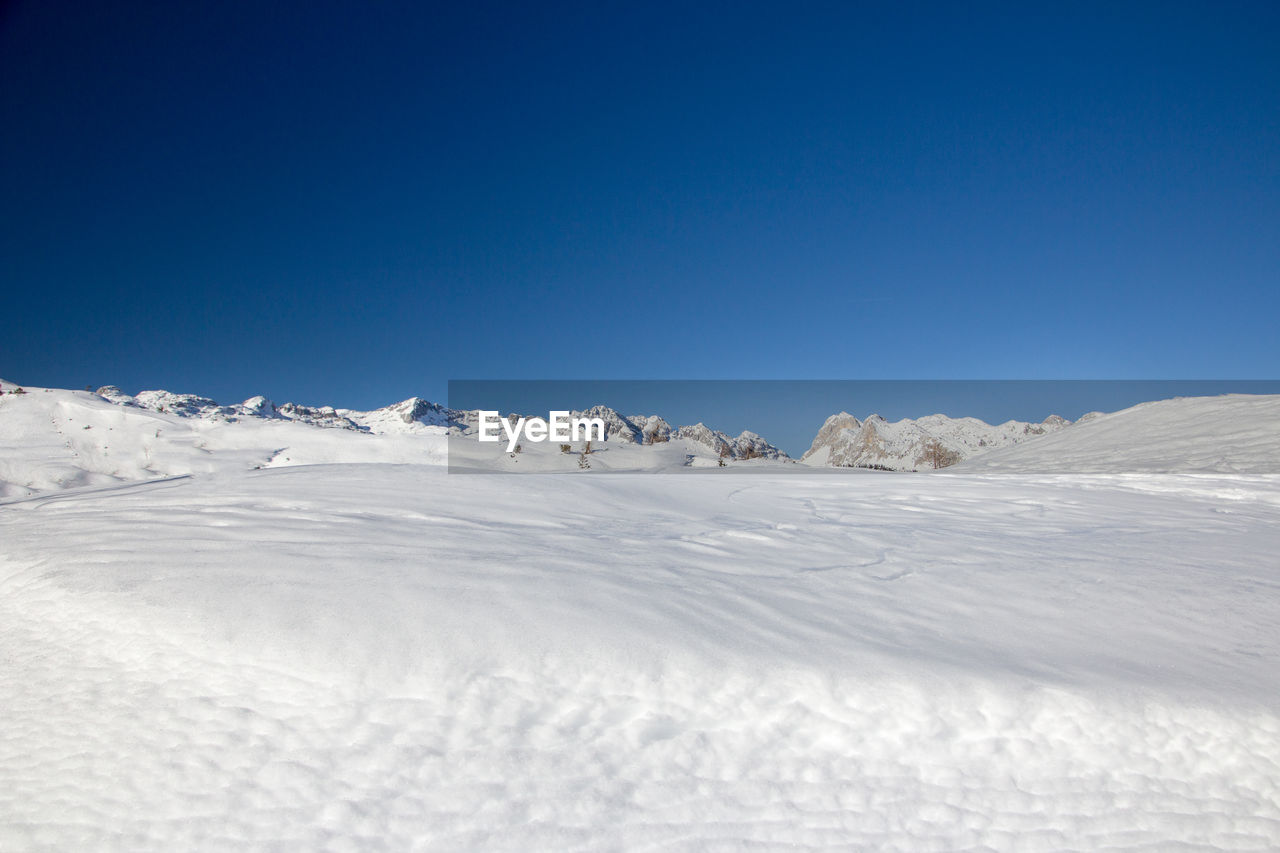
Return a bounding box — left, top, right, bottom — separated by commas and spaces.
964, 394, 1280, 474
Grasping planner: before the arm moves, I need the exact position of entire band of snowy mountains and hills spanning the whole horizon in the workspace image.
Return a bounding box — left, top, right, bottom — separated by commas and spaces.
0, 382, 1280, 500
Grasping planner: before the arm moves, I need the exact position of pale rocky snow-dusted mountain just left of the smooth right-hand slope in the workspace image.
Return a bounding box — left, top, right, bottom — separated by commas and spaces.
800, 411, 1075, 471
